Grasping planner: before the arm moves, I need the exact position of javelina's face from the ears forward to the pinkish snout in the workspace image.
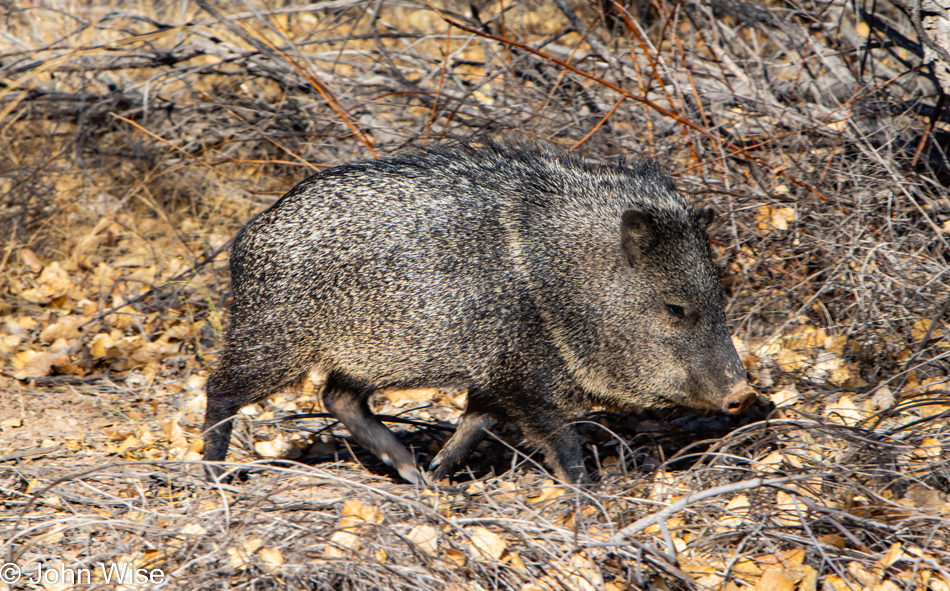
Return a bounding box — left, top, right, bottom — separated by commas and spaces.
615, 207, 755, 413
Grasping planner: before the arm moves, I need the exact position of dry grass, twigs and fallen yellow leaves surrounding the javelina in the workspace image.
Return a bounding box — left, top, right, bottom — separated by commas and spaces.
0, 0, 950, 591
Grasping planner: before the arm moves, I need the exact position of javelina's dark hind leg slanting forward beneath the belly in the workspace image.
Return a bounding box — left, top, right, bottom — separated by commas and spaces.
323, 375, 426, 485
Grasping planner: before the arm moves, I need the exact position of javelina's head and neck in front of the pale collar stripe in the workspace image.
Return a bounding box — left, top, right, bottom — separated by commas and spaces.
537, 157, 755, 413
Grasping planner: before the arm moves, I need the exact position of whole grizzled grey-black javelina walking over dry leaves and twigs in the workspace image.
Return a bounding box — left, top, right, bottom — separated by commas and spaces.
204, 141, 754, 483
